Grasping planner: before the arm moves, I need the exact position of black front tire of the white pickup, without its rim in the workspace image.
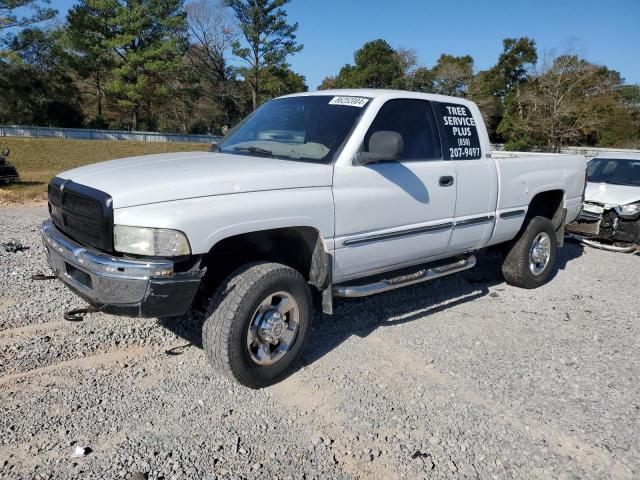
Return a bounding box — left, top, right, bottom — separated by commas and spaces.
202, 262, 313, 388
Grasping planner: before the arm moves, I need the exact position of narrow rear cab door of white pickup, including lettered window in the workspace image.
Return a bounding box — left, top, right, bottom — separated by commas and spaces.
431, 101, 498, 254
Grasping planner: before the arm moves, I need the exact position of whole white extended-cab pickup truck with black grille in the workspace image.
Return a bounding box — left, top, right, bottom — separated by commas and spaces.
41, 90, 586, 388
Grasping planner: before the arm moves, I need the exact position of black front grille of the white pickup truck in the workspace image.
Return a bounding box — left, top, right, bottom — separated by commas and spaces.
48, 178, 113, 251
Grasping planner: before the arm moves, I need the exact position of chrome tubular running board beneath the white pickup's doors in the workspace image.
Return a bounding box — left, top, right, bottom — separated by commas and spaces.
333, 255, 477, 298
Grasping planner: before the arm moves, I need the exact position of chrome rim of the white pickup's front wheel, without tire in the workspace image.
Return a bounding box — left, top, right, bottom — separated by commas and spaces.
247, 292, 300, 365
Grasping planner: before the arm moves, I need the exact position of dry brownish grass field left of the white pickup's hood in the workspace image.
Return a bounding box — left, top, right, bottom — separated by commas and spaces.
0, 137, 209, 204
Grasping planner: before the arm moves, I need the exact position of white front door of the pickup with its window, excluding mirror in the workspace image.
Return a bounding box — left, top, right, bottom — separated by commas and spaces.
333, 99, 456, 281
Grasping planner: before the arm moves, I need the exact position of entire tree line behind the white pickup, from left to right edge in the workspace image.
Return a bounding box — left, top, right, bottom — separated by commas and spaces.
0, 0, 640, 151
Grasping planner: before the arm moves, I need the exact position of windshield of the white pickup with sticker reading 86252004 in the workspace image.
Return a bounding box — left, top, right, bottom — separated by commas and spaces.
219, 95, 369, 163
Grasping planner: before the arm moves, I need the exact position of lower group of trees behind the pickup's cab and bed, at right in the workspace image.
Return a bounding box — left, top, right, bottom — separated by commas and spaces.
320, 37, 640, 151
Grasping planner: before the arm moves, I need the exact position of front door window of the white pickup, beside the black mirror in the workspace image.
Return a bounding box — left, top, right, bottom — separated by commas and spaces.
364, 99, 442, 160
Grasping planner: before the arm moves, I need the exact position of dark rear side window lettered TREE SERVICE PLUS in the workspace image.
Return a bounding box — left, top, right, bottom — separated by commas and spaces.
432, 102, 482, 160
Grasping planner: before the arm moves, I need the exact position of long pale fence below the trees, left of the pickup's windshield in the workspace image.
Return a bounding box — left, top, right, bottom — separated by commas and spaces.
0, 125, 220, 143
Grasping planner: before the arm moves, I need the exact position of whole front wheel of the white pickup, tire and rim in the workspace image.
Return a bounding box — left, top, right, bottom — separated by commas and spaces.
202, 262, 312, 388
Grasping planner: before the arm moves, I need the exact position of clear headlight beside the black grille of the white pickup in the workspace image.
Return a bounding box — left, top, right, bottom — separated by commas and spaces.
113, 225, 191, 257
